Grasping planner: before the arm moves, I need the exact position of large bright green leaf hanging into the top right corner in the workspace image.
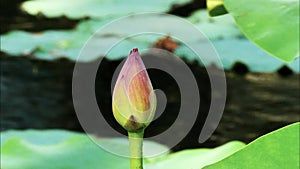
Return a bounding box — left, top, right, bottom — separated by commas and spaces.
224, 0, 300, 62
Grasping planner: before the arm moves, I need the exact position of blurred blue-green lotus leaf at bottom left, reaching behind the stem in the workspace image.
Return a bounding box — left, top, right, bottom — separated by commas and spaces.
1, 130, 168, 169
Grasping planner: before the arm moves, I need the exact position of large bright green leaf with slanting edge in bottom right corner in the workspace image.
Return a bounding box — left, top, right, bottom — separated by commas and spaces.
204, 122, 300, 169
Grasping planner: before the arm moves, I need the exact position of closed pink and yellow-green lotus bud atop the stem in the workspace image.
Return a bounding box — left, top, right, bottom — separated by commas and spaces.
112, 48, 156, 131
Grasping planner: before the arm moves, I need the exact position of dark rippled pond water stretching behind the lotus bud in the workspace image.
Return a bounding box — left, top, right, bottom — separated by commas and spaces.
0, 54, 300, 150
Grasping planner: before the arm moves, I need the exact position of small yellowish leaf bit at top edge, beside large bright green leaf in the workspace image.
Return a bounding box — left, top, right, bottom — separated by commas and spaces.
206, 0, 228, 16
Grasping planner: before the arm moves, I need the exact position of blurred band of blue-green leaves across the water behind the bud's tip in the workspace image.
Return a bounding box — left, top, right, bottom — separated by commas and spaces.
0, 10, 300, 72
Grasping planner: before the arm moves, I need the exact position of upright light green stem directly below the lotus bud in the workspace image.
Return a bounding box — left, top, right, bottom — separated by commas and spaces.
128, 130, 144, 169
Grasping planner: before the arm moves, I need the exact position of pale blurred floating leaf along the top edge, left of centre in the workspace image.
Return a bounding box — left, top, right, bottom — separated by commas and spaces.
22, 0, 191, 19
